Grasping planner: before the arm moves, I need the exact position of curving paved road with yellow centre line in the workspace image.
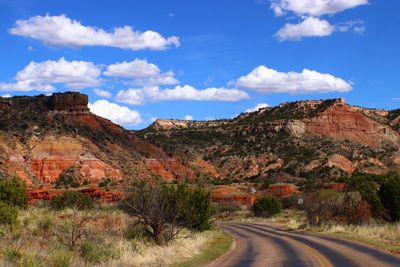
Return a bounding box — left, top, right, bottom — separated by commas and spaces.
210, 223, 400, 267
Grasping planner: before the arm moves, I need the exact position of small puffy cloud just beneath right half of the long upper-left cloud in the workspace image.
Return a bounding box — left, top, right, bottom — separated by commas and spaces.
104, 59, 178, 86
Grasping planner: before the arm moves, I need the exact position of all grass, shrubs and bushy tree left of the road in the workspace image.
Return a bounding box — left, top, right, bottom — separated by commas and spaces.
0, 178, 231, 267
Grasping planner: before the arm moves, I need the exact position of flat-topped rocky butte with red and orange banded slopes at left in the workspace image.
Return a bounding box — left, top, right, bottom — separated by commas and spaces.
0, 92, 191, 187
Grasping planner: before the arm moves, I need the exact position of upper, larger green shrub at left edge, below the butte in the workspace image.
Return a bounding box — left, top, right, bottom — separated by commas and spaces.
0, 177, 28, 208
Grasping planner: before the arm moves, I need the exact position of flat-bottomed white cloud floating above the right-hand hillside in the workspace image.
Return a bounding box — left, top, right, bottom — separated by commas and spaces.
236, 66, 352, 93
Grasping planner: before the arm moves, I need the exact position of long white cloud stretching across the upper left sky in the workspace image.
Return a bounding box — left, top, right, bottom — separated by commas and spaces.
10, 15, 180, 50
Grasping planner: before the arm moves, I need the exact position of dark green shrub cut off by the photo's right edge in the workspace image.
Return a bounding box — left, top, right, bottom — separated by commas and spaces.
379, 172, 400, 222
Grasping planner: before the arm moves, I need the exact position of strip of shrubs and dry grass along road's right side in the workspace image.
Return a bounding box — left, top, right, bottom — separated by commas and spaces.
218, 172, 400, 253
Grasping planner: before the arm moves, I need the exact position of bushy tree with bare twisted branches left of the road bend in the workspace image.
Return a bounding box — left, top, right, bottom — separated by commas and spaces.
122, 181, 212, 245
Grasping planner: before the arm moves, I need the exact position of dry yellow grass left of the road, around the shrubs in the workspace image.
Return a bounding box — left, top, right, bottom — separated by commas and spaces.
0, 207, 216, 266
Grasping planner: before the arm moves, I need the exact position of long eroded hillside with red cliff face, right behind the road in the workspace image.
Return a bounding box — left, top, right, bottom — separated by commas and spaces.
137, 99, 400, 182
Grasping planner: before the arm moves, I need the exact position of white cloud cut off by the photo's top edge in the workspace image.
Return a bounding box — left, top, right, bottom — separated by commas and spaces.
271, 0, 368, 17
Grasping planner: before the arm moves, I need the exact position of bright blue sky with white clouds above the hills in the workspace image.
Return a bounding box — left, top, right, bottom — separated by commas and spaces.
0, 0, 400, 129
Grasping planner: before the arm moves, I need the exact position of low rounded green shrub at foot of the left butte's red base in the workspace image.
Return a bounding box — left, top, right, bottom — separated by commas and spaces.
50, 191, 93, 210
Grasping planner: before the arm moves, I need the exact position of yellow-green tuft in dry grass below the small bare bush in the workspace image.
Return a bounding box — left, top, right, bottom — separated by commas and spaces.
80, 241, 116, 264
